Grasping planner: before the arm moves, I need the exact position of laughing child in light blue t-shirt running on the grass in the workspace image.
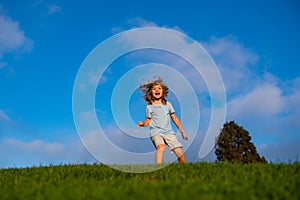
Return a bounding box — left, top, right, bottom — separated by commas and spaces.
137, 78, 188, 164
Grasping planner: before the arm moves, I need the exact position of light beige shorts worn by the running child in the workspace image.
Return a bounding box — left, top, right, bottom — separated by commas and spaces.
151, 134, 182, 151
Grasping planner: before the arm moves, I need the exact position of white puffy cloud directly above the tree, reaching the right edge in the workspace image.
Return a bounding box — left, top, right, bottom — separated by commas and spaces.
227, 74, 300, 127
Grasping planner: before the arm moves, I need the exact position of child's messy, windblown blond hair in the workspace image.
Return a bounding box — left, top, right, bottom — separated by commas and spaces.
140, 77, 169, 105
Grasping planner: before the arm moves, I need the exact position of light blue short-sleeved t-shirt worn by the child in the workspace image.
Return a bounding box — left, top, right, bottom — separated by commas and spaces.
146, 102, 175, 136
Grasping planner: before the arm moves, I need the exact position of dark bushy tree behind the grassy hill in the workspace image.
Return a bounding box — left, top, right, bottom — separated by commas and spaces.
215, 121, 267, 163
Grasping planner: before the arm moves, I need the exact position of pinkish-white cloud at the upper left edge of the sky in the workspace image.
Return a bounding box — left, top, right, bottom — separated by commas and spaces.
0, 15, 33, 58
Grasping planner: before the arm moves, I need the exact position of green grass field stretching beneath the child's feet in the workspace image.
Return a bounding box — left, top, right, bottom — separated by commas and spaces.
0, 163, 300, 200
